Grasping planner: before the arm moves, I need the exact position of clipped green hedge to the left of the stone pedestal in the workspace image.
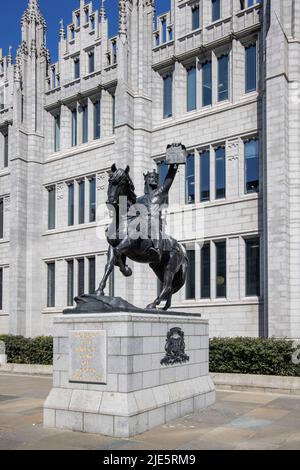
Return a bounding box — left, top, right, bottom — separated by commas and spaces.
0, 335, 53, 365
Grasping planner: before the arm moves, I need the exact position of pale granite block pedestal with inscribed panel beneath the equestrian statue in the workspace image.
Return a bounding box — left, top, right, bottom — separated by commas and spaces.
44, 313, 215, 437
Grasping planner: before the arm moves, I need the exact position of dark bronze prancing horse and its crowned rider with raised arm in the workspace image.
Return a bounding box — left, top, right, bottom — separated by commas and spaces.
96, 165, 188, 310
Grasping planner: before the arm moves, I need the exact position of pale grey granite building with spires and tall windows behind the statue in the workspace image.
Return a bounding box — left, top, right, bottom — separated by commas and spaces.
0, 0, 300, 338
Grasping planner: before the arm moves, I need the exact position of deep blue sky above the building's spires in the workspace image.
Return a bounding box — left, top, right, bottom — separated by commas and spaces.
0, 0, 170, 62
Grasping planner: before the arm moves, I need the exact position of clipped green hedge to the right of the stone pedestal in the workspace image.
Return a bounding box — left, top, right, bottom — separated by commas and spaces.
209, 338, 300, 377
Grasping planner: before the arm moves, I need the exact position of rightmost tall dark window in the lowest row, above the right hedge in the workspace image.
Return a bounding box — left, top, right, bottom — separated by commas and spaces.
245, 238, 260, 296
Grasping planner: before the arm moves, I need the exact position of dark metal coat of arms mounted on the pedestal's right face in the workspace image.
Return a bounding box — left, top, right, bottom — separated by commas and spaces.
160, 327, 190, 366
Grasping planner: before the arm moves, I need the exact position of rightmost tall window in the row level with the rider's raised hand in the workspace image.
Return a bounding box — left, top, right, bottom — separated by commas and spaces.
244, 139, 259, 193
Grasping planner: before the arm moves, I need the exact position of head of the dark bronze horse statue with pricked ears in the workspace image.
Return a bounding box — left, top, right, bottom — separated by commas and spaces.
107, 164, 136, 206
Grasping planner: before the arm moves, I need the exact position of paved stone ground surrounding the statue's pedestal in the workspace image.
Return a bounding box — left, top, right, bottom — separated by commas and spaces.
0, 374, 300, 450
